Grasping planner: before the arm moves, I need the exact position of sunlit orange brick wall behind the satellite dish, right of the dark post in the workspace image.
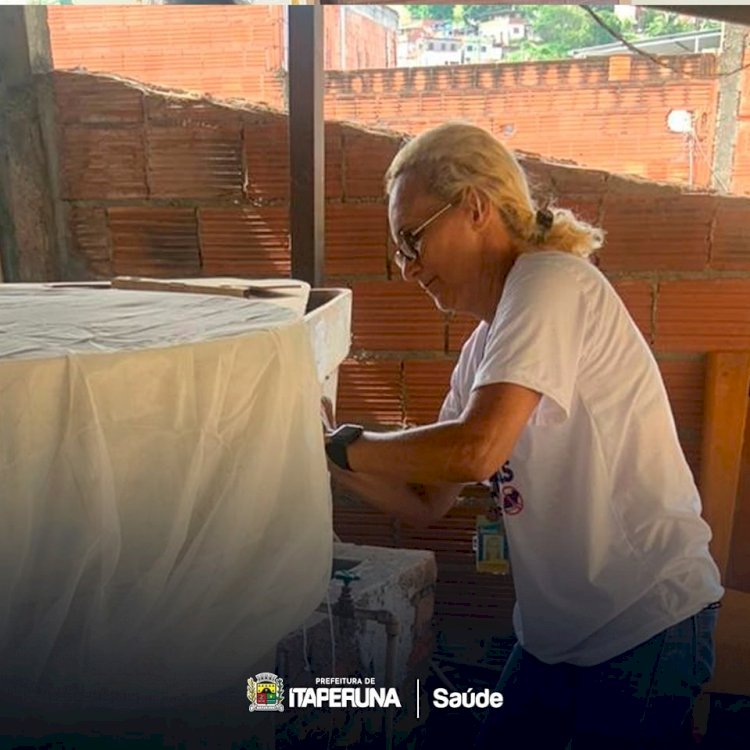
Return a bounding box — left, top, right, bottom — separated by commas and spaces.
326, 55, 717, 191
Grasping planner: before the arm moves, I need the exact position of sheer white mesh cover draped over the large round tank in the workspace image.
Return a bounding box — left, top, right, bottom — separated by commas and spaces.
0, 285, 332, 708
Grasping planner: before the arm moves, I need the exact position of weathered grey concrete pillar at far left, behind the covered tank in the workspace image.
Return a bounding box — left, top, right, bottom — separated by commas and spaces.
0, 5, 64, 281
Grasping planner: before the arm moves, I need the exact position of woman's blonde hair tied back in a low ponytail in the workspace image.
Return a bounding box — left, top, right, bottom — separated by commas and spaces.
385, 122, 604, 258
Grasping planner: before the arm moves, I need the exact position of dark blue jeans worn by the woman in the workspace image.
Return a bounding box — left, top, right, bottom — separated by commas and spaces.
476, 608, 719, 750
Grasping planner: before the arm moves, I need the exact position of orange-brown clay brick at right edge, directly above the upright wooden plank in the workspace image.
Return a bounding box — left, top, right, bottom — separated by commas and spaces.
654, 279, 750, 352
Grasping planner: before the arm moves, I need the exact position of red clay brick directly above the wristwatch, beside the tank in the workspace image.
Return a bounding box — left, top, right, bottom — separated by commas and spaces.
336, 359, 403, 426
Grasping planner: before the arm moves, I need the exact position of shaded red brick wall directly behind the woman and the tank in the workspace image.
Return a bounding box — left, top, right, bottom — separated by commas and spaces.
53, 72, 750, 627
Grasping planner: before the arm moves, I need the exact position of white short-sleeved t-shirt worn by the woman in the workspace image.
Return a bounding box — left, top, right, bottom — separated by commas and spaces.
440, 252, 724, 666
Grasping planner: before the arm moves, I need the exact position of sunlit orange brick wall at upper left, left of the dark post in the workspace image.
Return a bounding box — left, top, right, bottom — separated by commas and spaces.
47, 5, 286, 107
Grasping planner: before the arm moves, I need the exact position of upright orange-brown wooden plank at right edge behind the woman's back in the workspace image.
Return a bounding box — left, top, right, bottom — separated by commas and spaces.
700, 352, 750, 578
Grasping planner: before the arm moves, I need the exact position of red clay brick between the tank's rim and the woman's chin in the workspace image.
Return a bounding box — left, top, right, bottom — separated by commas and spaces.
352, 281, 445, 352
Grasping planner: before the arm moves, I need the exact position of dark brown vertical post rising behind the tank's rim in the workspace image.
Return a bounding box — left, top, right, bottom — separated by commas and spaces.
287, 5, 325, 287
